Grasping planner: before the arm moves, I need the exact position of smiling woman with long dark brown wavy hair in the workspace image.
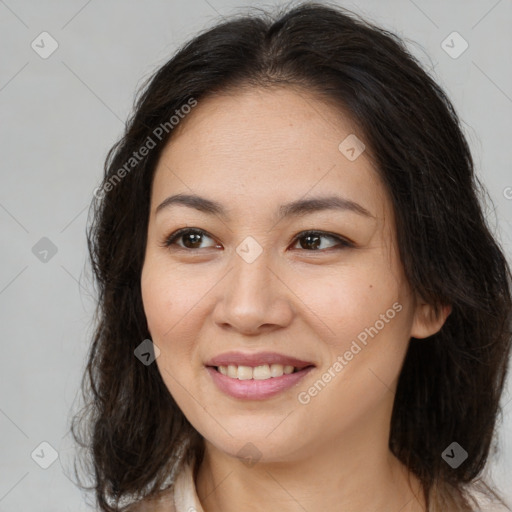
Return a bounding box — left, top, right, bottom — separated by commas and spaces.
71, 4, 511, 512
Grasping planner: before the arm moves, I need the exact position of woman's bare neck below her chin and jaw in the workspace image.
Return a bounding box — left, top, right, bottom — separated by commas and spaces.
196, 416, 426, 512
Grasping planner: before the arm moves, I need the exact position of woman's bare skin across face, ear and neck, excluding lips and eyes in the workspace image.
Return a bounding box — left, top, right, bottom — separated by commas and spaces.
141, 88, 449, 512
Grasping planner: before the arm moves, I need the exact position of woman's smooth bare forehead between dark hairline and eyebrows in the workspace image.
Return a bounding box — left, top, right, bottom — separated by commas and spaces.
152, 88, 389, 216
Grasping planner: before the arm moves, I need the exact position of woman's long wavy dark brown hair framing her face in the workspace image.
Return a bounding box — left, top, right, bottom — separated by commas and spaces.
72, 3, 512, 512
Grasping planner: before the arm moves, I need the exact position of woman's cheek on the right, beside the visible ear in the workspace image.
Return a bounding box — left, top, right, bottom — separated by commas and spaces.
301, 262, 412, 410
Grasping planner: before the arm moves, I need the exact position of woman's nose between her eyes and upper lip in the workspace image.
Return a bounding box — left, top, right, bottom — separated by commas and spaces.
213, 251, 294, 336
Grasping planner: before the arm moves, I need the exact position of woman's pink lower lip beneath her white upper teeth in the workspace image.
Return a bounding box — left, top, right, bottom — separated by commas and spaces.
206, 366, 314, 400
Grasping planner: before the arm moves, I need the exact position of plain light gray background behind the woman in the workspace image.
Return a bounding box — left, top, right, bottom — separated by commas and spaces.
0, 0, 512, 512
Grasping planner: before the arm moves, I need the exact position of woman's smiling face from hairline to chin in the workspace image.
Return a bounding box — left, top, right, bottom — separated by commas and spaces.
141, 89, 440, 461
